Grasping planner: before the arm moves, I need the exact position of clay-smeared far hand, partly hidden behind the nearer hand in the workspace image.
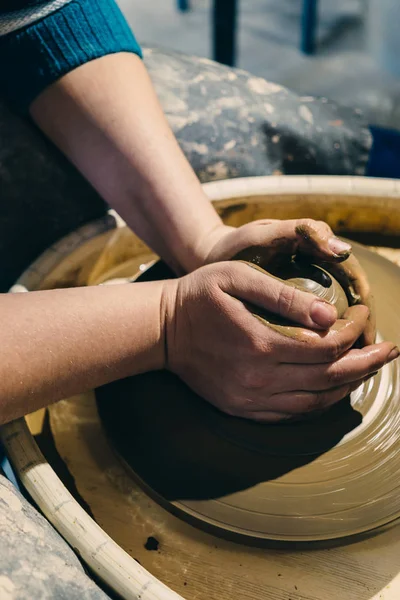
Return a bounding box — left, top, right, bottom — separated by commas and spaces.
204, 219, 376, 345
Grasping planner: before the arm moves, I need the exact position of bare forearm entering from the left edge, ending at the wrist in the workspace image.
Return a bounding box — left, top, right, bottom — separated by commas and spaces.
0, 282, 166, 423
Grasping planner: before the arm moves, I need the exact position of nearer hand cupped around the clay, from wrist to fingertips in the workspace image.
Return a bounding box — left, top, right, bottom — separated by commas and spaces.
162, 262, 399, 421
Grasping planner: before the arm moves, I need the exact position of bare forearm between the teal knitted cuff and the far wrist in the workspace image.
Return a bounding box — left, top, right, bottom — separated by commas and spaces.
31, 53, 225, 273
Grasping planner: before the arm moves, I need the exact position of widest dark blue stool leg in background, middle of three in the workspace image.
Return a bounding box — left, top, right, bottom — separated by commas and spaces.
212, 0, 238, 67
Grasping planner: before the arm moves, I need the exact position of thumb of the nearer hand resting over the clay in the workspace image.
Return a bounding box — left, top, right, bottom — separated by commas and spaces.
220, 262, 337, 329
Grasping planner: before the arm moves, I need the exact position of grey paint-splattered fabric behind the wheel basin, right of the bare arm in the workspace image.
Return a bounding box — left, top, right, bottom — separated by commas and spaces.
144, 48, 372, 181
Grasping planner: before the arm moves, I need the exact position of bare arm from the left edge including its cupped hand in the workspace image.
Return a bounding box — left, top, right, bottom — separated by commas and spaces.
0, 246, 399, 424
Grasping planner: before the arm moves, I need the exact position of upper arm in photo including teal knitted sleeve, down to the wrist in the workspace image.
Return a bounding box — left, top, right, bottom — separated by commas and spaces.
0, 0, 225, 273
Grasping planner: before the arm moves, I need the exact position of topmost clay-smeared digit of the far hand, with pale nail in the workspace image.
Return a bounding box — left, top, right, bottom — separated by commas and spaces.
232, 219, 351, 268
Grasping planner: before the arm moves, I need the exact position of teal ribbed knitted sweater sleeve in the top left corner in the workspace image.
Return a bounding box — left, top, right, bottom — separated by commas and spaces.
0, 0, 142, 112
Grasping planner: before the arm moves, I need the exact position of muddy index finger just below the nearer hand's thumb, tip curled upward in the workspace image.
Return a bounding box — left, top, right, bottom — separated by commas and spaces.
264, 306, 368, 366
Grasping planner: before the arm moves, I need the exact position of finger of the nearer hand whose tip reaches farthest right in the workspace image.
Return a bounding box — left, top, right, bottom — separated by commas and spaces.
280, 342, 399, 391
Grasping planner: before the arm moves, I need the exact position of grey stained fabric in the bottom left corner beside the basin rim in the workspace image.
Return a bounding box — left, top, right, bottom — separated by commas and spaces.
0, 475, 109, 600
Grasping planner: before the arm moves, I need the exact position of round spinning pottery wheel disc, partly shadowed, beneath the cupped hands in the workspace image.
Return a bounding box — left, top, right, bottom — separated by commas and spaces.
97, 245, 400, 541
